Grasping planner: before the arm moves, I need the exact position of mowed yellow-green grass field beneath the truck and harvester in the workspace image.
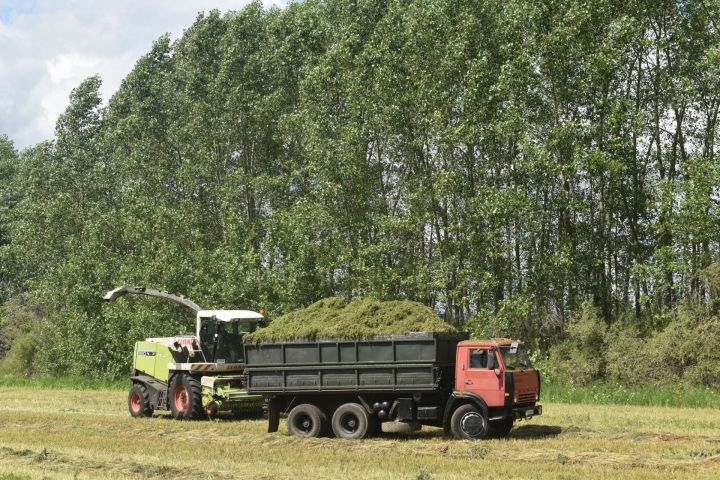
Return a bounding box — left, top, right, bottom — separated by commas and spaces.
0, 387, 720, 480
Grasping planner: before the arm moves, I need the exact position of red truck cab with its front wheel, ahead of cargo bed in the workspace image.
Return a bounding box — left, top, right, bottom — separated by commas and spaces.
446, 339, 542, 438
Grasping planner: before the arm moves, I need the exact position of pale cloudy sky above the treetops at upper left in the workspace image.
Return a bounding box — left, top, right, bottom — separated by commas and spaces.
0, 0, 288, 149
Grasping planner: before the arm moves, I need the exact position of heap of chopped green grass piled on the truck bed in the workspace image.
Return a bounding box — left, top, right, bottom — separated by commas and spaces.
246, 297, 456, 342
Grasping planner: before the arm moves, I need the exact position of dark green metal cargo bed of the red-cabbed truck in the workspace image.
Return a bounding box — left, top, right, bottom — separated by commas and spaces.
245, 333, 468, 394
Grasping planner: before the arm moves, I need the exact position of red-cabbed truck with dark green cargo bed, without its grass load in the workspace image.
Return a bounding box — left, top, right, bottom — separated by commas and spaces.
245, 333, 542, 439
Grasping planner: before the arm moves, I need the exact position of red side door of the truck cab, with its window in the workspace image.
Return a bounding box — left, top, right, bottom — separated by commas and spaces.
455, 347, 505, 407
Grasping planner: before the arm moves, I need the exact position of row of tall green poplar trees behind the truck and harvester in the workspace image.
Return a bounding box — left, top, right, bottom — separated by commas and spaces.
0, 0, 720, 375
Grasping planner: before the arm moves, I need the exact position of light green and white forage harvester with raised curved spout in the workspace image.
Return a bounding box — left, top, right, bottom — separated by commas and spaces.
103, 287, 264, 420
